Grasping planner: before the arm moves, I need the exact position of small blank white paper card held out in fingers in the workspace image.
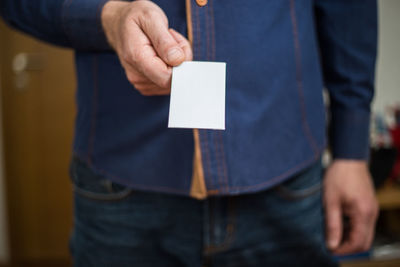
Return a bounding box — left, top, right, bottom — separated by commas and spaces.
168, 61, 226, 130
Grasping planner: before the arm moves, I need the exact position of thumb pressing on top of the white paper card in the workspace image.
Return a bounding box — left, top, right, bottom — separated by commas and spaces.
139, 12, 185, 66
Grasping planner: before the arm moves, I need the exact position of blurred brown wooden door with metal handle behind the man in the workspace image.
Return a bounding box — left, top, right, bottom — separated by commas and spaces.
0, 19, 75, 266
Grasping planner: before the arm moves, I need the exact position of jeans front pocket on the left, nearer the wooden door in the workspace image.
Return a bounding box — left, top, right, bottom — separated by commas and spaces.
70, 157, 133, 201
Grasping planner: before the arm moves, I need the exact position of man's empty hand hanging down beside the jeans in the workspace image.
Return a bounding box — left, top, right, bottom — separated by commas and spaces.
324, 160, 378, 255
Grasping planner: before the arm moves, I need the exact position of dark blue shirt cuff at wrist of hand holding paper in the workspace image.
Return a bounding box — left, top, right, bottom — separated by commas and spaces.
61, 0, 111, 51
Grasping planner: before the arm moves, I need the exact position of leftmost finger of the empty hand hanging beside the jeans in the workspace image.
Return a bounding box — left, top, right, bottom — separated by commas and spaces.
325, 199, 343, 250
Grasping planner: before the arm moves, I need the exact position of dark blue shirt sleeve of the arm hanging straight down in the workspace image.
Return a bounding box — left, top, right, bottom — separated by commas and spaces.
314, 0, 377, 160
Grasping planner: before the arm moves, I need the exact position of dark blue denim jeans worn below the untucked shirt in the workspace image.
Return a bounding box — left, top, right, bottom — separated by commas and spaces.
70, 159, 337, 267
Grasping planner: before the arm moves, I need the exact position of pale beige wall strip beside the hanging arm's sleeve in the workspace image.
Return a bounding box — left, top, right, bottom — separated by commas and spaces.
373, 0, 400, 112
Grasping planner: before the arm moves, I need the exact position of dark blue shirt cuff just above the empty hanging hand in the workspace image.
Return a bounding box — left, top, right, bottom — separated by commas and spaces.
330, 110, 370, 160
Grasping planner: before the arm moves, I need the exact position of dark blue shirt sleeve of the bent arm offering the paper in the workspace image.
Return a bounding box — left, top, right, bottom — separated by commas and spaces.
0, 0, 111, 51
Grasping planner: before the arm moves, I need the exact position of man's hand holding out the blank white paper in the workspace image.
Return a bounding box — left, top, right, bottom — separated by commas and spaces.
101, 0, 192, 95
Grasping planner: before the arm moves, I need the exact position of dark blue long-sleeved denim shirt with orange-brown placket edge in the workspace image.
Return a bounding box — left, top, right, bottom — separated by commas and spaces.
0, 0, 377, 198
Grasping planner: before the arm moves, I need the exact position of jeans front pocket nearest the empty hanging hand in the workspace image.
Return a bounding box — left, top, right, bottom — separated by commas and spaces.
275, 161, 323, 200
